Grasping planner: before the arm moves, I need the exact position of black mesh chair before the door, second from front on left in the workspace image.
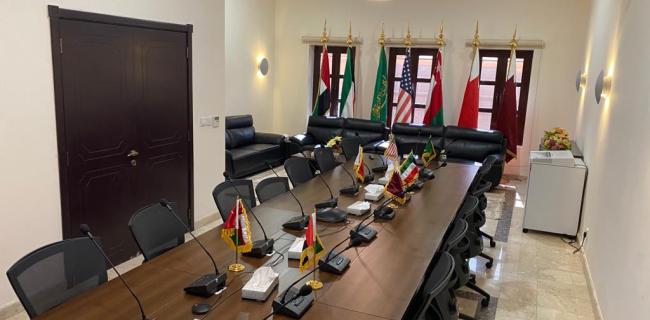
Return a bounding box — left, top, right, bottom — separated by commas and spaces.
129, 203, 185, 261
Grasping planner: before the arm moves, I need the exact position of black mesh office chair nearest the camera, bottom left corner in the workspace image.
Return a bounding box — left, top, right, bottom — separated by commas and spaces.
7, 238, 107, 318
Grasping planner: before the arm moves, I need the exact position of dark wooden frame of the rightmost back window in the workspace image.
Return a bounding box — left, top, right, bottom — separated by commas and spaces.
478, 49, 535, 146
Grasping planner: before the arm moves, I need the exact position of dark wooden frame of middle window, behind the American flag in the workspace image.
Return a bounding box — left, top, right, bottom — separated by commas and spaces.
386, 47, 439, 126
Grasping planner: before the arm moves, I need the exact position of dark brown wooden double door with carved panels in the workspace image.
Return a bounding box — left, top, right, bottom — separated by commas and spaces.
53, 11, 192, 262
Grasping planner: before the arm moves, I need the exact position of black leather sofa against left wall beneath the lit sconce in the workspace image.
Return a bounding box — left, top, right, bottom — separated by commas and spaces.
226, 115, 287, 178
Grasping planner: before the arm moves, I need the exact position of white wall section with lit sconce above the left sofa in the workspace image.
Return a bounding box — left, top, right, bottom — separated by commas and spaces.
225, 0, 276, 131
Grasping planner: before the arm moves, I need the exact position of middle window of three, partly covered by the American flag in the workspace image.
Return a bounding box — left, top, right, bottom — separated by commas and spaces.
388, 48, 438, 125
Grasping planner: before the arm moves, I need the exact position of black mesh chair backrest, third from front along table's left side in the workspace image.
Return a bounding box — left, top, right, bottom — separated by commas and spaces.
212, 179, 257, 221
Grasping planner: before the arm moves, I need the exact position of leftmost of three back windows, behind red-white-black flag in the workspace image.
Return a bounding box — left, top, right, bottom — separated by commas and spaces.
311, 46, 355, 117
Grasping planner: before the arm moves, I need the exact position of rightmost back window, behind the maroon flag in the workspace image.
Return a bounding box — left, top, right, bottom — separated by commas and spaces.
478, 50, 533, 145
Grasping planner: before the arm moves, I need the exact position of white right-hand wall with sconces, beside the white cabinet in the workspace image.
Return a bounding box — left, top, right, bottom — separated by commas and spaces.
577, 0, 650, 319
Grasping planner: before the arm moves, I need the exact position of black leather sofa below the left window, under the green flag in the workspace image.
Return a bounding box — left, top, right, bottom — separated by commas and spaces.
289, 116, 388, 154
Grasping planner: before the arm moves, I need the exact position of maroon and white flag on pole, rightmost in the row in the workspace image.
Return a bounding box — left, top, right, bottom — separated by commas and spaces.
495, 31, 519, 162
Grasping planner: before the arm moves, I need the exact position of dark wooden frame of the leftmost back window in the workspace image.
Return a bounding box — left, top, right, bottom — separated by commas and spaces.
311, 45, 356, 117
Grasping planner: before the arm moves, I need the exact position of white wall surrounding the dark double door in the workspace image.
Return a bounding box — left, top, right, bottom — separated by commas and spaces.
0, 0, 225, 307
